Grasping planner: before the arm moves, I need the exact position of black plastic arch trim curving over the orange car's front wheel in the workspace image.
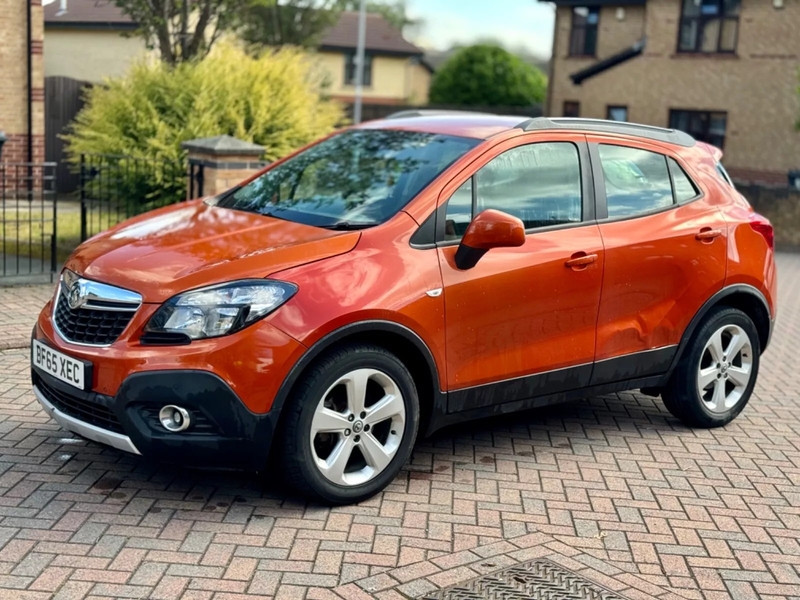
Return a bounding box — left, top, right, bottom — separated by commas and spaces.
270, 319, 447, 433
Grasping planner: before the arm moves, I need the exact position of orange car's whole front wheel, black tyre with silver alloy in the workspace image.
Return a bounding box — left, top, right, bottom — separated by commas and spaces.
282, 345, 419, 504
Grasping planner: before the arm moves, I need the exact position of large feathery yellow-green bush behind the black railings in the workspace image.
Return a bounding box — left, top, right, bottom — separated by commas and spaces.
65, 44, 343, 207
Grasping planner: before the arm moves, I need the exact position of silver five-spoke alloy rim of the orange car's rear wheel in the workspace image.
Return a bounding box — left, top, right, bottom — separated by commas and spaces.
697, 325, 753, 413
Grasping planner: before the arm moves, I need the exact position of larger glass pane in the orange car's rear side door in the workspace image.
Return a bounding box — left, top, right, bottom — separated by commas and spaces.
598, 144, 673, 219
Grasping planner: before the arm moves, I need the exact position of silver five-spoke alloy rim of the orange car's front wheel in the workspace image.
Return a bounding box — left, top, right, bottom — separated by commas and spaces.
311, 369, 406, 487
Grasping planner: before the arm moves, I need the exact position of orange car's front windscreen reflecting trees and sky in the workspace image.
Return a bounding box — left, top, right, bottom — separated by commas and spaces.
216, 129, 481, 229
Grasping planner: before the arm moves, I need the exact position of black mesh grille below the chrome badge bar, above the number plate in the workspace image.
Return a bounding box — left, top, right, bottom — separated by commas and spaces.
53, 292, 136, 346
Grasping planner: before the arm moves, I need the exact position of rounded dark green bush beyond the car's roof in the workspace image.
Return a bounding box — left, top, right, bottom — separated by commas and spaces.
430, 44, 547, 106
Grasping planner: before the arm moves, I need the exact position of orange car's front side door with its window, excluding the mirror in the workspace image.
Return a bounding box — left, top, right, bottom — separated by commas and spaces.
437, 134, 604, 412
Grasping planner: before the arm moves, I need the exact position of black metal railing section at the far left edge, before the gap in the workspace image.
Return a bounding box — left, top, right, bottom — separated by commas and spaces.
0, 162, 58, 283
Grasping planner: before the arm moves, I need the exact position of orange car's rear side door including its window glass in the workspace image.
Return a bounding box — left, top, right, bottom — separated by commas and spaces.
590, 137, 727, 385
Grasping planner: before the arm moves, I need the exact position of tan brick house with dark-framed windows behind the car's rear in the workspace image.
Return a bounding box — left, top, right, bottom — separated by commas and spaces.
540, 0, 800, 185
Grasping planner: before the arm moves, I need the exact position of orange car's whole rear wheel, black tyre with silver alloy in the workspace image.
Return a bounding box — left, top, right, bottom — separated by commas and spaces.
661, 307, 761, 428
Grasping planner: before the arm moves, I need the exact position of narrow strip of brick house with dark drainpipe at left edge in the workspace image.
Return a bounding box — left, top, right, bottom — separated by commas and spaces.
0, 0, 44, 162
